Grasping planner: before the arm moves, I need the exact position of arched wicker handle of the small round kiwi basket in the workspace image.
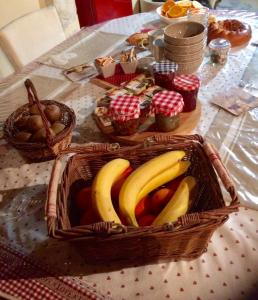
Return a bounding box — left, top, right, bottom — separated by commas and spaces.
24, 79, 54, 146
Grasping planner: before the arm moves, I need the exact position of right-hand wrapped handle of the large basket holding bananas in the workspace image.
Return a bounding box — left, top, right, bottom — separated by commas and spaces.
203, 142, 239, 206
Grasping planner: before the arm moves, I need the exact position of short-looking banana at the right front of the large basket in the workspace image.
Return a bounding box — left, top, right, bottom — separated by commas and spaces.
152, 176, 196, 225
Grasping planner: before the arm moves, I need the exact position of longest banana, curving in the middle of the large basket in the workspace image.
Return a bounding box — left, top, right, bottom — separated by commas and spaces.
119, 151, 185, 227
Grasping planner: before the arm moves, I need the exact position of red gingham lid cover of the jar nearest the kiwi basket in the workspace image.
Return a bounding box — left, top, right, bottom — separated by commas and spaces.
109, 95, 140, 121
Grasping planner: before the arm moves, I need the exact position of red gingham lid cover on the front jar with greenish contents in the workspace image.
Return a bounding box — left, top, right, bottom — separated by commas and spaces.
152, 91, 184, 117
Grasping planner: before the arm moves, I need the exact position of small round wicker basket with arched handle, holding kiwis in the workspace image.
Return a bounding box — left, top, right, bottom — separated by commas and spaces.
4, 79, 75, 161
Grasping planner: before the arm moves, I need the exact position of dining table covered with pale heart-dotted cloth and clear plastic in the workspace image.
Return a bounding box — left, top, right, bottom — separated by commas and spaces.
0, 10, 258, 300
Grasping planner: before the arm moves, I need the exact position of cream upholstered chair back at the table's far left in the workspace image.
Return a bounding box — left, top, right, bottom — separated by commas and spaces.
0, 6, 65, 70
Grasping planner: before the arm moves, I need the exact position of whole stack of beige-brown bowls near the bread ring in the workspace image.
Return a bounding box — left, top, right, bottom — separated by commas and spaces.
164, 21, 207, 74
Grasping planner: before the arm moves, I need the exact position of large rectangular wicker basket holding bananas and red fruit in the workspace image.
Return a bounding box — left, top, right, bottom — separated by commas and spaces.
46, 135, 239, 265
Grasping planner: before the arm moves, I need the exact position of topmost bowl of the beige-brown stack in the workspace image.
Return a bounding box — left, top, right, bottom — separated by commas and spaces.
164, 21, 206, 46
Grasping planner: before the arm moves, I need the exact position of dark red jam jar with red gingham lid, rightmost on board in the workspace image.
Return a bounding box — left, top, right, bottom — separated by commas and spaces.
174, 75, 200, 112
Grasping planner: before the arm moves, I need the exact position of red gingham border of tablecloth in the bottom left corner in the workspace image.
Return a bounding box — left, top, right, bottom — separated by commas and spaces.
0, 238, 107, 300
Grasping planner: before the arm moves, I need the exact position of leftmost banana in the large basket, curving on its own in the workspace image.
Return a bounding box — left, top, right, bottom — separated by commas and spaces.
92, 158, 130, 224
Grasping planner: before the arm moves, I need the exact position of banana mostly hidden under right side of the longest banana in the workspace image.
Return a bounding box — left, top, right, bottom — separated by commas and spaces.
137, 161, 191, 201
